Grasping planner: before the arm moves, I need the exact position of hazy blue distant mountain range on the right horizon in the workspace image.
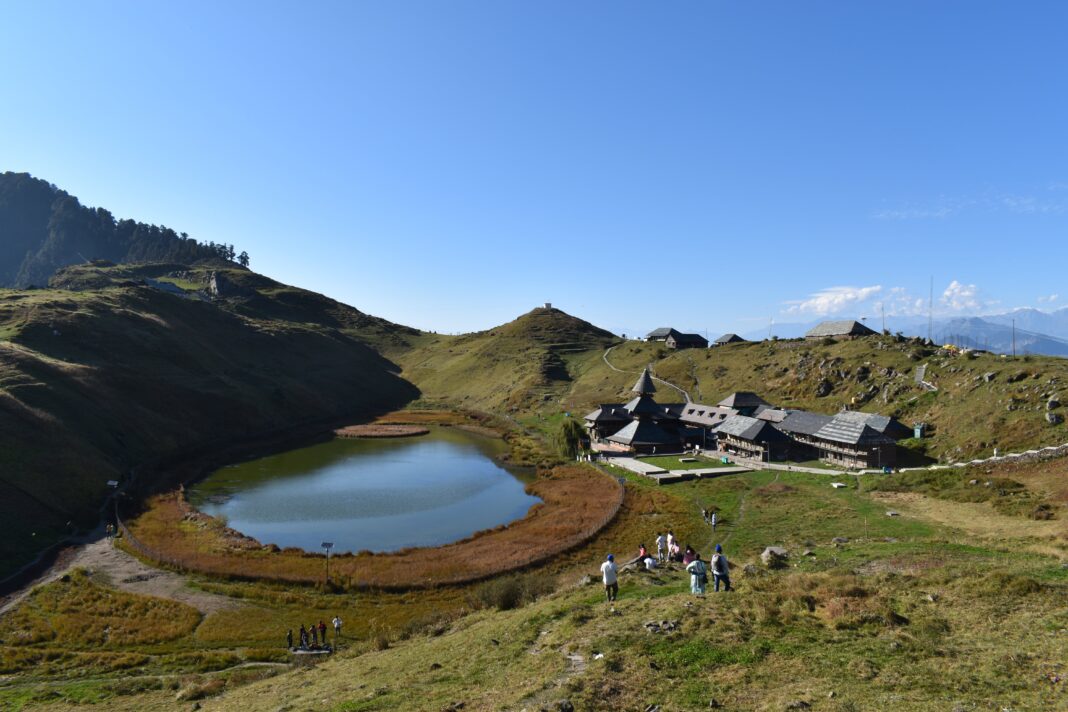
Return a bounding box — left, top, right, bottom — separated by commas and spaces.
742, 307, 1068, 357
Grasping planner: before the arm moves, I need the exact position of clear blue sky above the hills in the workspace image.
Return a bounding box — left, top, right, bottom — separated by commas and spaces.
0, 0, 1068, 332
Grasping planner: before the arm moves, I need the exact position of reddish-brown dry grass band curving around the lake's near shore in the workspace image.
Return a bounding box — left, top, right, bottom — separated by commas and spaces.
121, 465, 623, 589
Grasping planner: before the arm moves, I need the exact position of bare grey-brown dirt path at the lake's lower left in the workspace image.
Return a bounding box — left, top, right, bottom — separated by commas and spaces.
0, 538, 239, 615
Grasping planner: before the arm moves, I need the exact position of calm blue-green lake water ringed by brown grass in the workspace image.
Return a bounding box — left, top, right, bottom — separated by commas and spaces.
186, 428, 540, 553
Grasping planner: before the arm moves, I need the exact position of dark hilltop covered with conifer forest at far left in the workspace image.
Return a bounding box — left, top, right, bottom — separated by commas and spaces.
0, 172, 249, 288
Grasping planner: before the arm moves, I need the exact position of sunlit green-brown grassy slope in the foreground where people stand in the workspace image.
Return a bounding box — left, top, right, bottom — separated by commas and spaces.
0, 463, 1068, 712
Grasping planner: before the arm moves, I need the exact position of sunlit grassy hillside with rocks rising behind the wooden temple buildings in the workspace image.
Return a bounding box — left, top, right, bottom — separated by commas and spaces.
391, 322, 1068, 460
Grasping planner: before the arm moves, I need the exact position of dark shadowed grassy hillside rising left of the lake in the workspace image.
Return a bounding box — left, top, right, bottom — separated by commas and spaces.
0, 261, 418, 572
